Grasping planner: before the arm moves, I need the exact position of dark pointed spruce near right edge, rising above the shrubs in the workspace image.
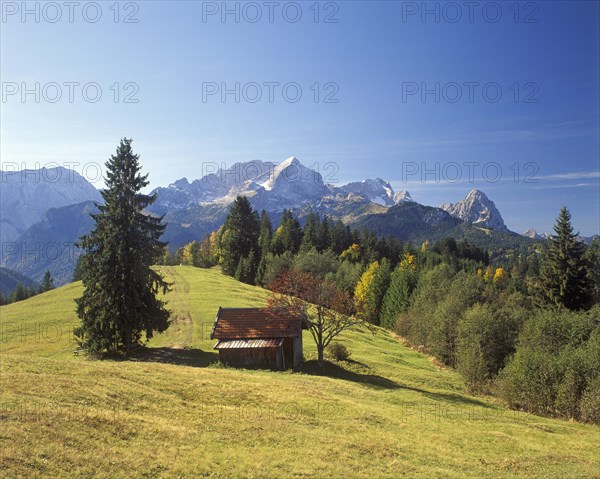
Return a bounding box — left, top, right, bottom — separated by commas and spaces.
541, 206, 589, 310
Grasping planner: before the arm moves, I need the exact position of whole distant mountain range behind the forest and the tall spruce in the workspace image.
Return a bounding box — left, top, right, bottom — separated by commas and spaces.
0, 156, 564, 285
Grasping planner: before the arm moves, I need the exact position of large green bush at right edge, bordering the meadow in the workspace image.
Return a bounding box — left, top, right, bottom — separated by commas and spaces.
496, 309, 600, 422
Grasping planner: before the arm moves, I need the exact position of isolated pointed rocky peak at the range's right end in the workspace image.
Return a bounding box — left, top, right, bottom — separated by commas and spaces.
440, 190, 508, 231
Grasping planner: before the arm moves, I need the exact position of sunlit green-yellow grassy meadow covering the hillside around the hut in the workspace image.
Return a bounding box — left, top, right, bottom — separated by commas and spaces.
0, 267, 600, 479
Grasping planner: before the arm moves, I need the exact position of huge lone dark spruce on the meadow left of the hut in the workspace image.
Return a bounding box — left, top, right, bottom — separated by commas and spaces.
75, 138, 169, 355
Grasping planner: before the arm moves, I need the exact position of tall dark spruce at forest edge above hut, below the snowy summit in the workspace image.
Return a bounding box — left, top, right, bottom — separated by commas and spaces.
221, 196, 260, 276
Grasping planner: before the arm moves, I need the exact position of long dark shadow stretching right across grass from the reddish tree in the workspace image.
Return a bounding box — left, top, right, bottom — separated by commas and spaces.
301, 359, 494, 408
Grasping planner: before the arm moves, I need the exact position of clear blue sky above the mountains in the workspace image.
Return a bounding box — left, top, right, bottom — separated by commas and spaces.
0, 1, 600, 235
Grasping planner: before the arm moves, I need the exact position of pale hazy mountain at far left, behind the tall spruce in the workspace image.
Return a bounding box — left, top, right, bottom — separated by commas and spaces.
0, 167, 101, 243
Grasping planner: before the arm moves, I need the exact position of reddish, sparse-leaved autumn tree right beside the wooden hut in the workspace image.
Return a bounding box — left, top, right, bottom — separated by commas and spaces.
268, 270, 368, 367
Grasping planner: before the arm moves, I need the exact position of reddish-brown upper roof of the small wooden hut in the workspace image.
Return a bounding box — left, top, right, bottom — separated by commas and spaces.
210, 308, 302, 339
